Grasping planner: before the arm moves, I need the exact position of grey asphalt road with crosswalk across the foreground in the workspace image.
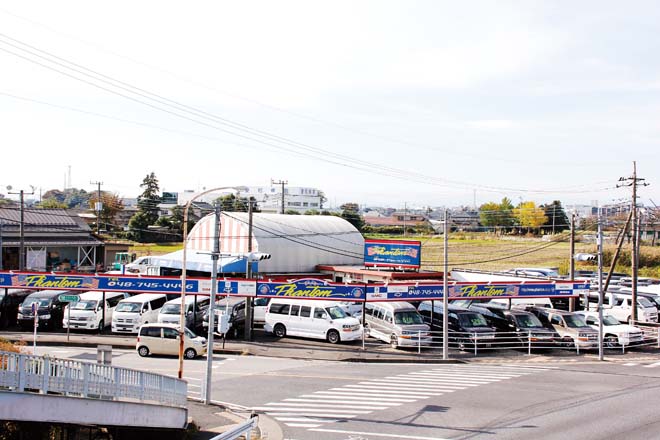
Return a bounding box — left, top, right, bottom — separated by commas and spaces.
38, 347, 660, 440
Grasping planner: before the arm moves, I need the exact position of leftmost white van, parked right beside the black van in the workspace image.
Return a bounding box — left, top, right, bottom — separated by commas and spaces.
62, 291, 129, 331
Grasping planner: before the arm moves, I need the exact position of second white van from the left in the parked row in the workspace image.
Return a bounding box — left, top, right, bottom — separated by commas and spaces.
112, 293, 167, 333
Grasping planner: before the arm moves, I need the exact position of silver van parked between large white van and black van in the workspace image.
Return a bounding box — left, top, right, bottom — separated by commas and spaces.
365, 301, 433, 348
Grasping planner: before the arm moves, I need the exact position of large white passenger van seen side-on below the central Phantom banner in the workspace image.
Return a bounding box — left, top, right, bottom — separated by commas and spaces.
264, 298, 363, 344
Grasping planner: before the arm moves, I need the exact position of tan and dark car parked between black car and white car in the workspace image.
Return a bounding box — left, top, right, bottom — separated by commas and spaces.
528, 307, 598, 349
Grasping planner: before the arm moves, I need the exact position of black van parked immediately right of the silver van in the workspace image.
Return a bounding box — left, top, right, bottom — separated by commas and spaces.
417, 301, 498, 350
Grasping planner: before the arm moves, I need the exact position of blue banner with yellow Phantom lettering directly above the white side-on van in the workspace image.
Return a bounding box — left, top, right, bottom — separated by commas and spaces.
257, 278, 365, 301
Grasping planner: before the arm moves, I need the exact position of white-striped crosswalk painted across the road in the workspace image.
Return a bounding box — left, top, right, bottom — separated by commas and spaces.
252, 365, 556, 429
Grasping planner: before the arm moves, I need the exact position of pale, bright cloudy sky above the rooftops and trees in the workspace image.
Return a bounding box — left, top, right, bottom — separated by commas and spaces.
0, 0, 660, 208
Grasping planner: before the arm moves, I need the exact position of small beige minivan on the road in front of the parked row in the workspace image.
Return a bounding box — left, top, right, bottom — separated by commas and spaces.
135, 323, 207, 359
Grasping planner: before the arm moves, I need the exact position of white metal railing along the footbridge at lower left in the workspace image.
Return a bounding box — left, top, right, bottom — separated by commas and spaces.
0, 351, 188, 407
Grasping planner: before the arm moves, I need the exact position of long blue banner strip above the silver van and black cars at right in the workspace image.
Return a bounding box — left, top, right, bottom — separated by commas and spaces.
367, 283, 589, 301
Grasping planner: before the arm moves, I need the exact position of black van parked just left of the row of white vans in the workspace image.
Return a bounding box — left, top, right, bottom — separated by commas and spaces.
18, 290, 70, 330
